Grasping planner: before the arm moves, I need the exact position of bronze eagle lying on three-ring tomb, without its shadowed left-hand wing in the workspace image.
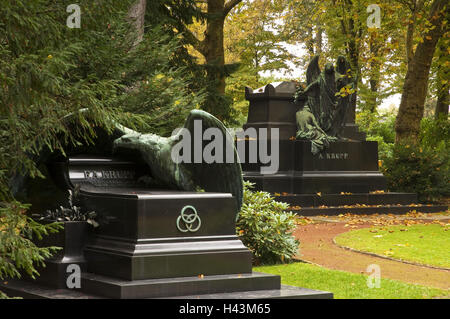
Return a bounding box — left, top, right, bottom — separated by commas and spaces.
113, 110, 243, 210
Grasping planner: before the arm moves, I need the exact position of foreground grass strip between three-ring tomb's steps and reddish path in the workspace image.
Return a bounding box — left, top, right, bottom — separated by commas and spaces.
253, 262, 450, 299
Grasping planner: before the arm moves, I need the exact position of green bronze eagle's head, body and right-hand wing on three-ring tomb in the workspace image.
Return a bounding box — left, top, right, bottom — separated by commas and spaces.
114, 110, 243, 218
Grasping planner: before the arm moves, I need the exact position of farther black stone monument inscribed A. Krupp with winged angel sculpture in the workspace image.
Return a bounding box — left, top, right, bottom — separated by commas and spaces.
242, 56, 446, 216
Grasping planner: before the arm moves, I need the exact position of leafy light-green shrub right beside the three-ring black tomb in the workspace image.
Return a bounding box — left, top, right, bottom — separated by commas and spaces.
236, 182, 299, 263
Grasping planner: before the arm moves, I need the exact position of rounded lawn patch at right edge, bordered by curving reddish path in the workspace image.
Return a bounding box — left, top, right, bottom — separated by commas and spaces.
335, 224, 450, 268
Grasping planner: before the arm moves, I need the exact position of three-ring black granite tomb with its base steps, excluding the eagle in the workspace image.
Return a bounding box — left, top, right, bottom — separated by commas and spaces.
0, 156, 332, 299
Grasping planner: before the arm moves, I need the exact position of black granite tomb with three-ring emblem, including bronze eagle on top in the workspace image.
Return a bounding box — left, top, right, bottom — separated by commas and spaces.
0, 110, 332, 299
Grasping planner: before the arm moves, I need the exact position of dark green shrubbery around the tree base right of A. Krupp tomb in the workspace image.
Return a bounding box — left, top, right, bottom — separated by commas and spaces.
356, 111, 450, 202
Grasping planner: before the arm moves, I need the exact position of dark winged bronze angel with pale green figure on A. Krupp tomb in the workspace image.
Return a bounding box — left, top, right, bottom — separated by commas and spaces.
295, 55, 353, 154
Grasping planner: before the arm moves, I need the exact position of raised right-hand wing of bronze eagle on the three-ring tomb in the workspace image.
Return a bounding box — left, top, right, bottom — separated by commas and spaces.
181, 110, 243, 215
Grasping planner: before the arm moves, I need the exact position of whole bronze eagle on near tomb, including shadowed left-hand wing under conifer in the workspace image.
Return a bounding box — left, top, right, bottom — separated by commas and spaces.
10, 109, 243, 218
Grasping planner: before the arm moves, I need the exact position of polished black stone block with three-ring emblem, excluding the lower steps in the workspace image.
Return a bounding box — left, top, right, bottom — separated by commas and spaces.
49, 155, 252, 280
